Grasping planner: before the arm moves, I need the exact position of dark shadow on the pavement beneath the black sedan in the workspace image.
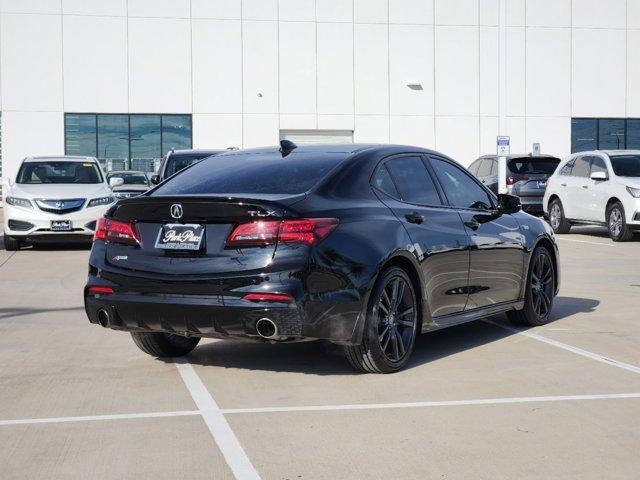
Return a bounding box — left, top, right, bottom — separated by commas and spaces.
176, 297, 600, 375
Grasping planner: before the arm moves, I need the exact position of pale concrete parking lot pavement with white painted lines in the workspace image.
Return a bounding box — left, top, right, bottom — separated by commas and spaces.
0, 206, 640, 480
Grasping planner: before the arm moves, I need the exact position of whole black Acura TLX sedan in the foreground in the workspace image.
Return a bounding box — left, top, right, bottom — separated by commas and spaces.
84, 141, 560, 373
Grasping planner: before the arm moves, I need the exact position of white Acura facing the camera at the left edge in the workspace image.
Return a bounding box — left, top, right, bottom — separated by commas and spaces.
4, 156, 115, 250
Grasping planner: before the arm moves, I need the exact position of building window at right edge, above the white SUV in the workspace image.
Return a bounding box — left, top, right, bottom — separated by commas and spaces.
571, 118, 640, 153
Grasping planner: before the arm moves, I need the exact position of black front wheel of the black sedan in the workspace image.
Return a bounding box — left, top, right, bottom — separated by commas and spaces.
507, 246, 556, 327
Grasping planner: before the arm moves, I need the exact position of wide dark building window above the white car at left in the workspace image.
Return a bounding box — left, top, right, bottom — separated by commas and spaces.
65, 113, 192, 171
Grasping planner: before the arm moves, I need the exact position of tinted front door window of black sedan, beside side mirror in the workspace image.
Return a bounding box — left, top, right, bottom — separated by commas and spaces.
431, 158, 493, 209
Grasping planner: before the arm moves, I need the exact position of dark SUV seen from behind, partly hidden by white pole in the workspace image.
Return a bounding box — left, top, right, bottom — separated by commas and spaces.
469, 154, 560, 214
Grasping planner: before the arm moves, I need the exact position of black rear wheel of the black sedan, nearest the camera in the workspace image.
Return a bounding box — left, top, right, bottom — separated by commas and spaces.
345, 267, 419, 373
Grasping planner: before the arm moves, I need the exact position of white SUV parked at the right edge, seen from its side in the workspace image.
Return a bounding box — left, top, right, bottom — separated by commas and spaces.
543, 150, 640, 241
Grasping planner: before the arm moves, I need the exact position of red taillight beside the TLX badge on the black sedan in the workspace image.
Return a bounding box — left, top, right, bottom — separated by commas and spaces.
227, 218, 338, 247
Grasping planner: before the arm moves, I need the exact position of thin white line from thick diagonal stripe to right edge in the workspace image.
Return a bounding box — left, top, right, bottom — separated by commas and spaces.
222, 393, 640, 415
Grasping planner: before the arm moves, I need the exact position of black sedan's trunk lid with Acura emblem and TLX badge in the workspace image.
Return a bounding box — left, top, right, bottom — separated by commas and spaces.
106, 194, 304, 275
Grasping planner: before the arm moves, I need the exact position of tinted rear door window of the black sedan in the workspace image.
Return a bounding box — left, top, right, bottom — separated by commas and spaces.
386, 157, 442, 205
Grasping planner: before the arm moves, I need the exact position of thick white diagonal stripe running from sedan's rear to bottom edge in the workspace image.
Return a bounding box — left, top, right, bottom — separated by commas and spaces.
173, 357, 260, 480
